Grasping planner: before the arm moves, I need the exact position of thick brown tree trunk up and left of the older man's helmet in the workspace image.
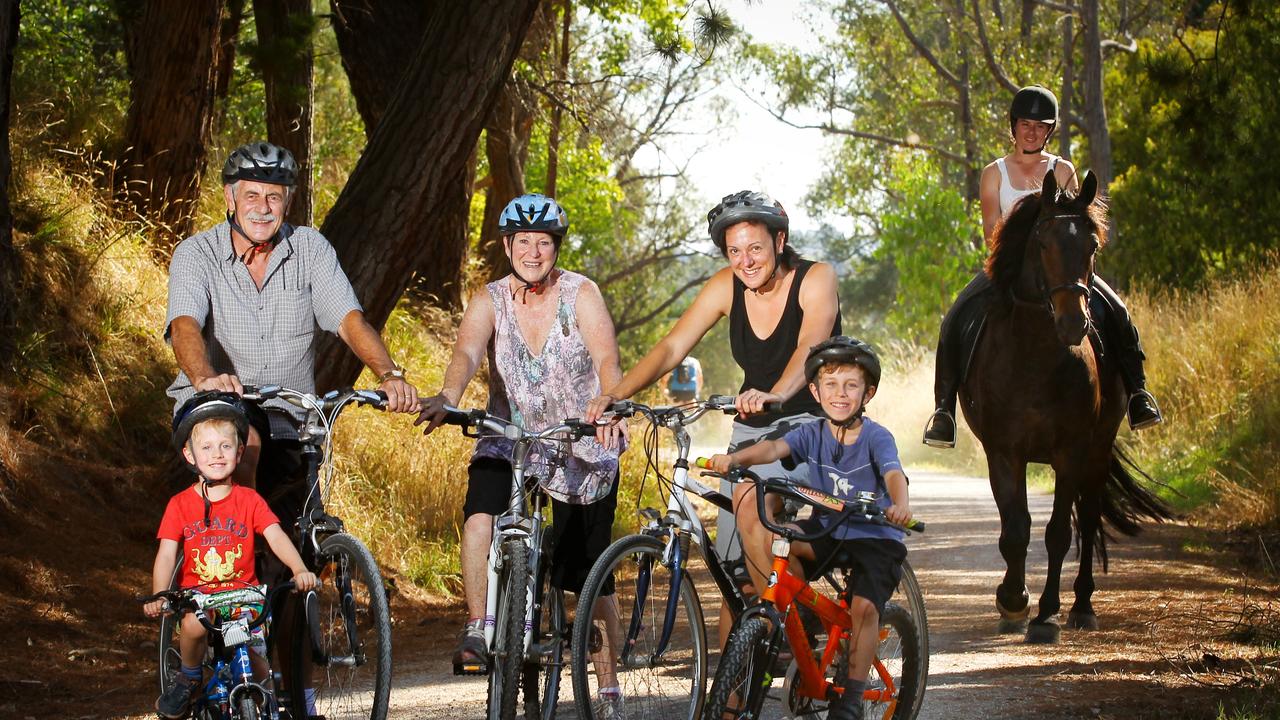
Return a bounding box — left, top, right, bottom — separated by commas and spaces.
118, 0, 224, 254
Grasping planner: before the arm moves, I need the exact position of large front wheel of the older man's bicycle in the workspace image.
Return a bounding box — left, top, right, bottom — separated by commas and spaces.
289, 533, 392, 720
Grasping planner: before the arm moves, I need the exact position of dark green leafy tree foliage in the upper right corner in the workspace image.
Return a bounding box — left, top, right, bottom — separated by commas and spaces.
1107, 1, 1280, 287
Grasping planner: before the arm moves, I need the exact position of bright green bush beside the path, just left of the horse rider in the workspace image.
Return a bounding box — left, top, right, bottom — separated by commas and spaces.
876, 152, 982, 342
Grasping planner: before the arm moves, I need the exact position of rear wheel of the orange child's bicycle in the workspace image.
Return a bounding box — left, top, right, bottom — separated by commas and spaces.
863, 602, 924, 720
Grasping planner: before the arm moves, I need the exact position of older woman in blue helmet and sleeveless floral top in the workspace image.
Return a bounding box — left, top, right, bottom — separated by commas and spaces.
417, 195, 622, 705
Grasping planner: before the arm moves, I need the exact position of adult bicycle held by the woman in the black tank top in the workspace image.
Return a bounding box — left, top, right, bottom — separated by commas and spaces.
570, 395, 928, 720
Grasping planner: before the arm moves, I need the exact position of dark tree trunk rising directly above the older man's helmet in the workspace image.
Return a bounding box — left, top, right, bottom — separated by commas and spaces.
253, 0, 315, 225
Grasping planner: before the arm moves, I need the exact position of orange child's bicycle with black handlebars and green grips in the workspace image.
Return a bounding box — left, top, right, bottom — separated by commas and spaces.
699, 460, 927, 720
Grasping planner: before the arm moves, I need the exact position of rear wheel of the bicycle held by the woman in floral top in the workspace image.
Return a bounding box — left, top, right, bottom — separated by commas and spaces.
521, 542, 568, 720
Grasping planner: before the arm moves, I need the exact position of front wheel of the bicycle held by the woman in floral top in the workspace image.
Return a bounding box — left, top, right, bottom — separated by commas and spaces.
488, 538, 529, 720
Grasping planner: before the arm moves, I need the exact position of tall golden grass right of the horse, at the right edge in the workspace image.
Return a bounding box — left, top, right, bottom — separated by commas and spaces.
1125, 263, 1280, 524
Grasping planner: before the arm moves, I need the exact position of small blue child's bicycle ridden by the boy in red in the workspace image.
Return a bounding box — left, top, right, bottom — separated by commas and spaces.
140, 582, 293, 720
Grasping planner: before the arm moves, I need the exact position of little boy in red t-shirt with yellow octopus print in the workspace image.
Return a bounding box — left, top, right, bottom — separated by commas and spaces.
143, 392, 316, 717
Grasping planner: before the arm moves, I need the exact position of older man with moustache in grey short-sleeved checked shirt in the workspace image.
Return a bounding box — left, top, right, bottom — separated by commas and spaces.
165, 142, 419, 497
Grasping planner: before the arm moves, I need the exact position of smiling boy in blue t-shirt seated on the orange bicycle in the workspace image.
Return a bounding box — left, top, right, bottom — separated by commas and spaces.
710, 336, 911, 720
